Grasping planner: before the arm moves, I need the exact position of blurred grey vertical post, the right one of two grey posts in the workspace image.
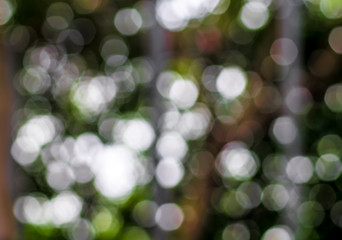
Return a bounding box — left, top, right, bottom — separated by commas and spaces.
278, 0, 303, 232
